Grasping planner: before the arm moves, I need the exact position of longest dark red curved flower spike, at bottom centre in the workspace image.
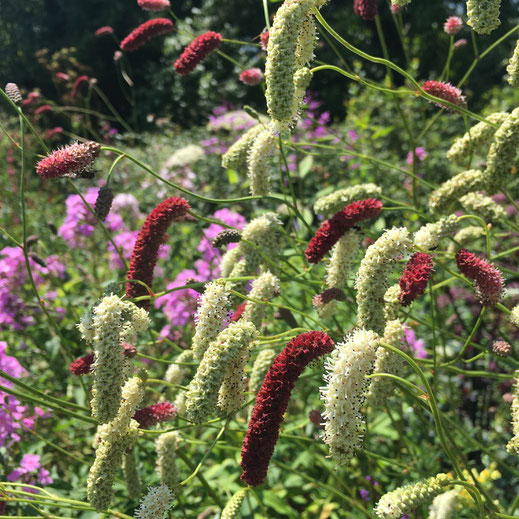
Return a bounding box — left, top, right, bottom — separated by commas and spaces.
241, 331, 334, 486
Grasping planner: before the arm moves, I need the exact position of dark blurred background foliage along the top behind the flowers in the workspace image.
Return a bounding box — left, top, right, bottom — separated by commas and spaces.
0, 0, 518, 130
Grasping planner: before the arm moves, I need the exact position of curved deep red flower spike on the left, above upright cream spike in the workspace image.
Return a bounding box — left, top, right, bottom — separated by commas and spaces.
126, 196, 191, 309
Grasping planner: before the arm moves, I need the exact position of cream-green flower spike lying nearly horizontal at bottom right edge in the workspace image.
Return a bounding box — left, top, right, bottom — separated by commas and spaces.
375, 474, 451, 519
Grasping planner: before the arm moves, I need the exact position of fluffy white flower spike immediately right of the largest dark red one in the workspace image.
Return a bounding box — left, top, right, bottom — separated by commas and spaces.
321, 329, 379, 465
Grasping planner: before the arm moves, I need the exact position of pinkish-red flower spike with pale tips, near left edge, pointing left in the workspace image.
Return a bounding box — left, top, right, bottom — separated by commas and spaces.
36, 141, 101, 178
